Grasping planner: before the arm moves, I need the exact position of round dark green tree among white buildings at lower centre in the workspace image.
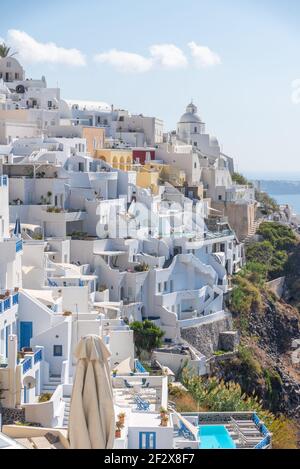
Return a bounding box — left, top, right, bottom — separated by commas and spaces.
130, 320, 164, 357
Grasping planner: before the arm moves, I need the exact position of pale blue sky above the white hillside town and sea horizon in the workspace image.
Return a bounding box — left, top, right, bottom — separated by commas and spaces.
0, 0, 300, 173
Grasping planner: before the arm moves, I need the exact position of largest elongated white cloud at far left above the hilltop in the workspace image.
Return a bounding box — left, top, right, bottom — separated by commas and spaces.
7, 29, 86, 66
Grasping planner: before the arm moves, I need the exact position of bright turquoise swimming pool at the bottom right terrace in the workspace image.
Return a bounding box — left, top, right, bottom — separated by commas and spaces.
199, 425, 236, 449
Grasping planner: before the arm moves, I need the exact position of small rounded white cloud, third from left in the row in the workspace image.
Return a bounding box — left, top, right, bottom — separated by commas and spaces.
150, 44, 188, 68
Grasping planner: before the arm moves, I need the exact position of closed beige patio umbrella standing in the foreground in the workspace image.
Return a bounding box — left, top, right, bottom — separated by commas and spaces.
68, 335, 115, 449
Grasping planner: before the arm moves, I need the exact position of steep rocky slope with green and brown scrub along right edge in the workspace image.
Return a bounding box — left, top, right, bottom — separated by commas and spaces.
218, 222, 300, 447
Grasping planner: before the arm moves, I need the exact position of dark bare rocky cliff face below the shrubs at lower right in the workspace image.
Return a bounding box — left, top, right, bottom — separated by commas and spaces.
213, 298, 300, 420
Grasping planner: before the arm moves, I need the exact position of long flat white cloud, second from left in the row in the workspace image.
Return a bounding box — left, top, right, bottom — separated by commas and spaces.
94, 49, 152, 73
